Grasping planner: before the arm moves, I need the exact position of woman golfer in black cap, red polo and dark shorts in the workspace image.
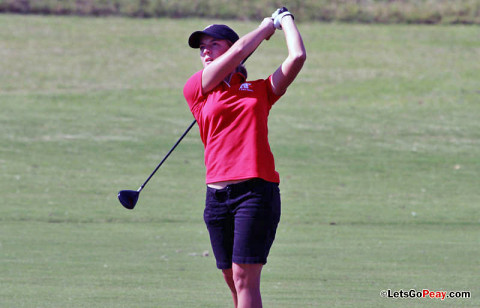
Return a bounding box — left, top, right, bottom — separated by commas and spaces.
183, 8, 306, 308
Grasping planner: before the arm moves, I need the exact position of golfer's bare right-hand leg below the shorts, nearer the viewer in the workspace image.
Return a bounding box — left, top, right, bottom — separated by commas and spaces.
232, 263, 263, 308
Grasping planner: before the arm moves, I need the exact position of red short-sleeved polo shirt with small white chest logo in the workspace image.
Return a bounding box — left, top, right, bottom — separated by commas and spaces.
183, 70, 280, 184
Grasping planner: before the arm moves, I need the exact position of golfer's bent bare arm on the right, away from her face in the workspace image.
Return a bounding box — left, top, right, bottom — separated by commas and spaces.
272, 15, 307, 95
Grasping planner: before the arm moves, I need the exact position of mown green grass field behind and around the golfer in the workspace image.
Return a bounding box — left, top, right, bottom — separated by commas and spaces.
0, 15, 480, 308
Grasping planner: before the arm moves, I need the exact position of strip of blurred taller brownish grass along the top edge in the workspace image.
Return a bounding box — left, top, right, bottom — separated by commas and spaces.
0, 0, 480, 24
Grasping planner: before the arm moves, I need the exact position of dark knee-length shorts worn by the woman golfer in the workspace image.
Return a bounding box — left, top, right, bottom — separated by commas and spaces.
204, 179, 281, 269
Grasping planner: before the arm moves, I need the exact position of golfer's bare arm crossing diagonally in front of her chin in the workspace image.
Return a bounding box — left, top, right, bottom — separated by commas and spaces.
202, 18, 275, 93
